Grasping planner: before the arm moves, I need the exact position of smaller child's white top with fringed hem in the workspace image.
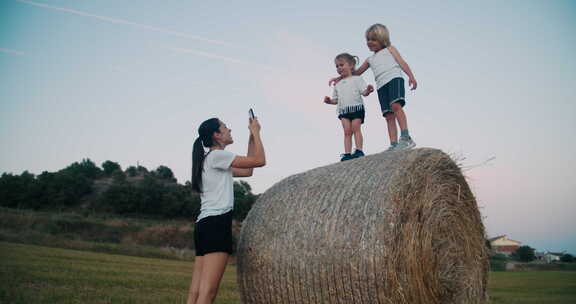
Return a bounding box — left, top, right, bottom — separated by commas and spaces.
332, 76, 368, 114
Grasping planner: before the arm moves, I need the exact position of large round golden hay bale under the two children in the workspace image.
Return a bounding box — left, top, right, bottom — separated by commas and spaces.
237, 148, 488, 304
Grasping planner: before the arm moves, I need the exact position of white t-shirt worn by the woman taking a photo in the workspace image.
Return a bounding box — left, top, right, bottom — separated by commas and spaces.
196, 150, 236, 222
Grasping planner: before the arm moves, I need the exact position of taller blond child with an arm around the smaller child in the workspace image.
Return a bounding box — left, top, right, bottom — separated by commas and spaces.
329, 24, 417, 151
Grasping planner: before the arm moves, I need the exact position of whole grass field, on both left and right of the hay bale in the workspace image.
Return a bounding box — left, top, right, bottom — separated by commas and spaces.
0, 242, 576, 304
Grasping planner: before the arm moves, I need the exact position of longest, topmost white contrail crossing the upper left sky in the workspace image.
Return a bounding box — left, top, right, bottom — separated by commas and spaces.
16, 0, 237, 47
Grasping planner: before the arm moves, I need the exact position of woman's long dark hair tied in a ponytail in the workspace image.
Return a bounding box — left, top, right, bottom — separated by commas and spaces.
192, 118, 220, 193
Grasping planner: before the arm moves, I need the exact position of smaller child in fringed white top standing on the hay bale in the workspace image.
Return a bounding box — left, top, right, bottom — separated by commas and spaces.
324, 53, 374, 161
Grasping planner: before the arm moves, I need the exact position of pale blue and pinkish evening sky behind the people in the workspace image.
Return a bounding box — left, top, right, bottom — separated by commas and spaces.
0, 0, 576, 254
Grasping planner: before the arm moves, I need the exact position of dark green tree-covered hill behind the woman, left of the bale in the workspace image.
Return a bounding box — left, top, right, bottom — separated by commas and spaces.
0, 159, 257, 220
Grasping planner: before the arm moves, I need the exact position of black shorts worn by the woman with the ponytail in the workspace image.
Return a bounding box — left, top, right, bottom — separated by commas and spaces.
194, 211, 232, 256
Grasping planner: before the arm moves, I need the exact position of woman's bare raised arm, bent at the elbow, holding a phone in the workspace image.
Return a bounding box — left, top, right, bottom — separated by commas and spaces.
231, 119, 266, 177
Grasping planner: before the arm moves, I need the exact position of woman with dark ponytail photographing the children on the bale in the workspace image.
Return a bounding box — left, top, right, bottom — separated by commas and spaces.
187, 118, 266, 304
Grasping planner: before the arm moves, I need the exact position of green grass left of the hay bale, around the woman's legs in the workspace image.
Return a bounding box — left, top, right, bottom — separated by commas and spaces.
0, 242, 239, 304
